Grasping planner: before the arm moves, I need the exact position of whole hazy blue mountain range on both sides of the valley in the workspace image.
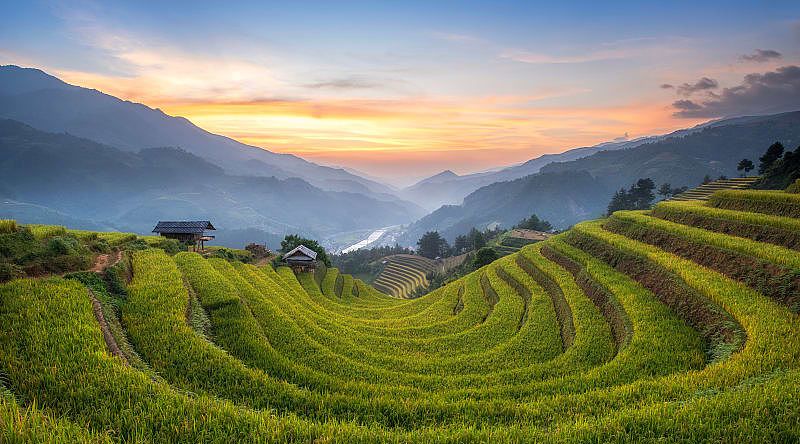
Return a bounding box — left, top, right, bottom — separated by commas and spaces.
0, 66, 800, 250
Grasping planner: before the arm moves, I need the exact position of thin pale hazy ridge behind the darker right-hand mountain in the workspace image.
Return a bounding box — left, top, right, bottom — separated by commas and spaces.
399, 116, 792, 210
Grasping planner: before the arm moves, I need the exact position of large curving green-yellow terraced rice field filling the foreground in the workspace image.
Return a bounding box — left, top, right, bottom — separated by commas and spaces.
0, 187, 800, 443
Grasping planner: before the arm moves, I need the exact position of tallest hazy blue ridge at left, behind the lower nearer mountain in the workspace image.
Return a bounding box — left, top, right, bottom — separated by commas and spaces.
0, 65, 400, 199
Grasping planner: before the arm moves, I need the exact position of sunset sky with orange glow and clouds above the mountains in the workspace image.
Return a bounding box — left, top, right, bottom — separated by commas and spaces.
0, 0, 800, 185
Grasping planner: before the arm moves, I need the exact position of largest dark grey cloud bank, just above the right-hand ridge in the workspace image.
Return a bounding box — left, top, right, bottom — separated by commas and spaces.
672, 65, 800, 118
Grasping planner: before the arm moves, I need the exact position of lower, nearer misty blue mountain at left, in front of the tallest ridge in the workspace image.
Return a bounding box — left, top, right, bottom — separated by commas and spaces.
0, 120, 422, 248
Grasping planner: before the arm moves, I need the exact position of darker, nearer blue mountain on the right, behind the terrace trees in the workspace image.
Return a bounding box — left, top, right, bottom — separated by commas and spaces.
401, 111, 800, 245
